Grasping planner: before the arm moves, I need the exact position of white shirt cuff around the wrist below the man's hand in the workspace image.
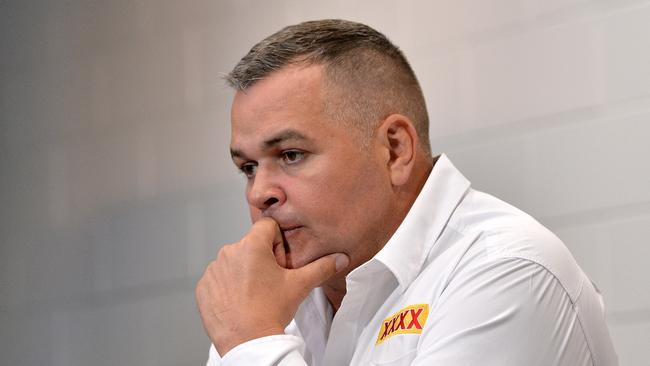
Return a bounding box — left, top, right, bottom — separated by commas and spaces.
206, 334, 307, 366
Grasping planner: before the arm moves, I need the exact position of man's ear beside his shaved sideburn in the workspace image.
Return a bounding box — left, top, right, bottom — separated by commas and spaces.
377, 114, 419, 186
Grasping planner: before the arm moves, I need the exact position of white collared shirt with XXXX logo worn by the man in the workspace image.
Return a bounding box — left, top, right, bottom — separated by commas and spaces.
207, 155, 618, 366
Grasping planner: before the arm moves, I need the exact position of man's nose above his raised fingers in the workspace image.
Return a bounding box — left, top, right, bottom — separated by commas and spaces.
246, 166, 287, 214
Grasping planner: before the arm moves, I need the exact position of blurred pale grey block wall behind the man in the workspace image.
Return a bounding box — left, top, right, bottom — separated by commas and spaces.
0, 0, 650, 366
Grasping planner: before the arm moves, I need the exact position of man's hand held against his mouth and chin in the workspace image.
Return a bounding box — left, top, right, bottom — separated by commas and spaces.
196, 218, 349, 356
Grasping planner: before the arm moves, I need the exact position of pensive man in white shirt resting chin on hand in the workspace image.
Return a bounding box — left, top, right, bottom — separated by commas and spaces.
196, 20, 617, 366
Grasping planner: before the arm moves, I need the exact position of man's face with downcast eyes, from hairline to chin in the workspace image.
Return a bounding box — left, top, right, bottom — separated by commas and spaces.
230, 66, 392, 268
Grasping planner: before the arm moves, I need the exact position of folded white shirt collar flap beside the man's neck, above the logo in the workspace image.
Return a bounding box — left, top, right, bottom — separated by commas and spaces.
368, 154, 470, 291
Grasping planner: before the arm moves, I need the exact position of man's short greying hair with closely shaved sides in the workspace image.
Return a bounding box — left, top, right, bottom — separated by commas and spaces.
225, 19, 431, 154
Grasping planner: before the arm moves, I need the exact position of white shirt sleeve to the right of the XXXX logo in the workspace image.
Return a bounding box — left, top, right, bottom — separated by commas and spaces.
409, 258, 604, 366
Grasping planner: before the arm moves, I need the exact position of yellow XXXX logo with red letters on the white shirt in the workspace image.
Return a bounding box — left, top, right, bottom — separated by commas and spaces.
375, 304, 429, 345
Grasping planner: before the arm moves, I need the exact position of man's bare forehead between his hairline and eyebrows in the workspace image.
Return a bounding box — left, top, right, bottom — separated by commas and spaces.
231, 65, 330, 148
